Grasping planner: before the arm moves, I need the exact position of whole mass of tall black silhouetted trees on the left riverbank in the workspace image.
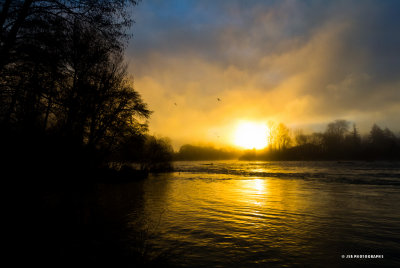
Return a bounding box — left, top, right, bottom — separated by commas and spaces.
0, 0, 172, 176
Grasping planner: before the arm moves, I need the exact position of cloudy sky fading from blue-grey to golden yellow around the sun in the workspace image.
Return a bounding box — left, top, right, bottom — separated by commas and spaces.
126, 0, 400, 149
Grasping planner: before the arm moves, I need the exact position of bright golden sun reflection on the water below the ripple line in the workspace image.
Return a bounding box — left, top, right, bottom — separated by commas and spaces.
141, 173, 324, 261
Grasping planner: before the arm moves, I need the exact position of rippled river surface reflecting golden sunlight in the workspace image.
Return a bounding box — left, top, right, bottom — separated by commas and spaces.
94, 161, 400, 267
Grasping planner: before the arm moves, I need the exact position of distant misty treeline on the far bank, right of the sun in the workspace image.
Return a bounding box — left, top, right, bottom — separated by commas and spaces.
240, 120, 400, 161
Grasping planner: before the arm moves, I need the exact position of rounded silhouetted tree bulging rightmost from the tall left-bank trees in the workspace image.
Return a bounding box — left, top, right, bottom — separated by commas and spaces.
57, 25, 150, 157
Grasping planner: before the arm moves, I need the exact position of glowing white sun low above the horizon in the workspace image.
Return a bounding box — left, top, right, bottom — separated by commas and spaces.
234, 122, 269, 149
